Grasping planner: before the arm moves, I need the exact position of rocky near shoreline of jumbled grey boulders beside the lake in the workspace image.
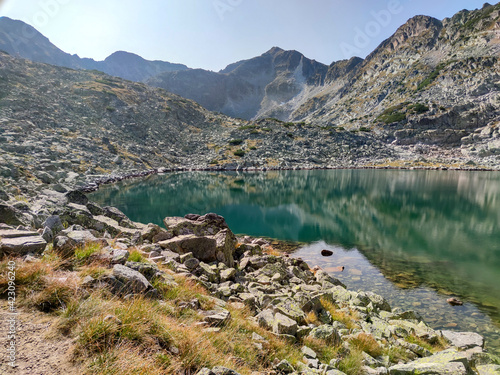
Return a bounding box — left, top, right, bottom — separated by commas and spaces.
0, 184, 500, 375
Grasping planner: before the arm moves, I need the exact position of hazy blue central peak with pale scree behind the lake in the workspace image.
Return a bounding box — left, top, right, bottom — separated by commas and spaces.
147, 47, 328, 119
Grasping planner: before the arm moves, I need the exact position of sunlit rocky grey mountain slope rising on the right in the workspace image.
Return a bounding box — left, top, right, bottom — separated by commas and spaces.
292, 4, 500, 156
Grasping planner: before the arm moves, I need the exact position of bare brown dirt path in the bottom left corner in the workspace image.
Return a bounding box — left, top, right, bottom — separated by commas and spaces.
0, 300, 80, 375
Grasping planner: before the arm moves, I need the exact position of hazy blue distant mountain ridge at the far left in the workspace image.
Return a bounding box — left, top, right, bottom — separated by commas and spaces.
0, 17, 188, 82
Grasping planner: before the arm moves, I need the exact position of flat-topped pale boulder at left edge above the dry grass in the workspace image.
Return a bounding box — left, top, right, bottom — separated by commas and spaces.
0, 229, 47, 256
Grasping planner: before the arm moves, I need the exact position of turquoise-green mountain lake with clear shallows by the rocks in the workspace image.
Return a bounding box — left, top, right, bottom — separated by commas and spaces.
91, 170, 500, 356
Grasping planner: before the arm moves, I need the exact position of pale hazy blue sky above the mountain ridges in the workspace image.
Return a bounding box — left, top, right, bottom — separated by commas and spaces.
0, 0, 492, 71
